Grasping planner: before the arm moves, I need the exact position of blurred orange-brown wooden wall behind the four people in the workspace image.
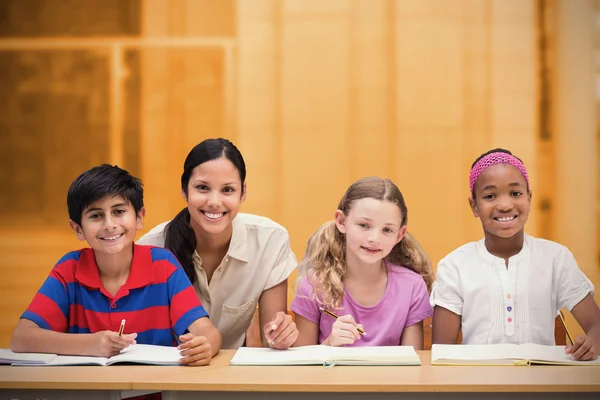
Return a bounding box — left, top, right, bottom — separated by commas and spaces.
0, 0, 600, 347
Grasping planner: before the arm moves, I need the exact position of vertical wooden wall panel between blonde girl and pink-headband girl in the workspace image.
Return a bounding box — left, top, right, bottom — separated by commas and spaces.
394, 1, 470, 263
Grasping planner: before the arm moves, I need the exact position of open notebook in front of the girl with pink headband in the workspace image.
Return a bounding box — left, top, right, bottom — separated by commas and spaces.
431, 343, 600, 366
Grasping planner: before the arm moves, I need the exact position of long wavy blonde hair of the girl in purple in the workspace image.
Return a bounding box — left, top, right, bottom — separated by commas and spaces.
297, 177, 433, 308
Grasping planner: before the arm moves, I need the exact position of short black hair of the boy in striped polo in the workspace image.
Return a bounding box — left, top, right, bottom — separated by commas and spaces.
67, 164, 144, 225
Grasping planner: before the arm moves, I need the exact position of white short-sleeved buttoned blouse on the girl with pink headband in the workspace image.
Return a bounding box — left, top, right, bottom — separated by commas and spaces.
430, 235, 594, 345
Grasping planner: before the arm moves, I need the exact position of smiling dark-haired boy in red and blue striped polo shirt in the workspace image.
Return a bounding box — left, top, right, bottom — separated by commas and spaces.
11, 164, 221, 365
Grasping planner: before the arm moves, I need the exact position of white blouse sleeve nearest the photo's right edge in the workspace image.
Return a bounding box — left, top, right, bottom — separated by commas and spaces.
554, 248, 594, 311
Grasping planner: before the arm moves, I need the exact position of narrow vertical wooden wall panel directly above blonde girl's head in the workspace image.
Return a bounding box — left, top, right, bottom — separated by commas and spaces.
346, 0, 396, 179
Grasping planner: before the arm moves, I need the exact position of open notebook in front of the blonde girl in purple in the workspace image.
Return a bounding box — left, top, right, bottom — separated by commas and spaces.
230, 345, 421, 365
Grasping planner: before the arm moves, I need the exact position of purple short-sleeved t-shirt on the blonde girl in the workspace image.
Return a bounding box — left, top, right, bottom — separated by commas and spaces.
290, 263, 432, 346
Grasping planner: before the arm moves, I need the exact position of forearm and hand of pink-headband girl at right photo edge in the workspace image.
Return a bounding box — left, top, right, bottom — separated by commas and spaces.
566, 293, 600, 361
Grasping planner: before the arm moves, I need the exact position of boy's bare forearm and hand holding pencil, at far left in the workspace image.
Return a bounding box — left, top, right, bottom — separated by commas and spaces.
10, 318, 137, 357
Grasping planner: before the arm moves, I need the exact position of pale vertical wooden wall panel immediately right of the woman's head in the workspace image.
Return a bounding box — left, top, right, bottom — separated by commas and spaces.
235, 0, 284, 221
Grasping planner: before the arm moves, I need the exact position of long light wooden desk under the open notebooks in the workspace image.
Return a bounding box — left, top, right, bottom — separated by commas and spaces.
0, 350, 600, 400
